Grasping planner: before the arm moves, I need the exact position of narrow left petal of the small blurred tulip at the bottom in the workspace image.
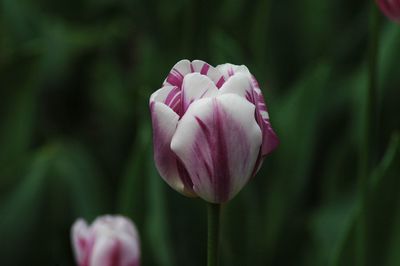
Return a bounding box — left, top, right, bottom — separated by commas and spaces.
71, 219, 94, 266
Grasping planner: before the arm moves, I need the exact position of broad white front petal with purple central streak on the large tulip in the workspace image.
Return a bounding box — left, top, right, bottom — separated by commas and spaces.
171, 94, 261, 203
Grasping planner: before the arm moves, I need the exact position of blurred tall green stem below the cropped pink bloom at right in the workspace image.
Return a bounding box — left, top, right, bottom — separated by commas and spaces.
357, 0, 379, 266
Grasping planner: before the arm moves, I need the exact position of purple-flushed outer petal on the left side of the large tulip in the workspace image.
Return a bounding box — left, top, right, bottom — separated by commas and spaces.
150, 102, 195, 196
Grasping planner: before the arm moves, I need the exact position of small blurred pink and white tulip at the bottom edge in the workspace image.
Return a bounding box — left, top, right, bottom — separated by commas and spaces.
71, 215, 140, 266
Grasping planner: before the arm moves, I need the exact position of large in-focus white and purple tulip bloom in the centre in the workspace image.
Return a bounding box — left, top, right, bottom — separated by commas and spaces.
150, 60, 278, 203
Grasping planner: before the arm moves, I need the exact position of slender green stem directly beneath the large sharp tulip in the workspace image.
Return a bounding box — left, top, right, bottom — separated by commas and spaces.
207, 203, 221, 266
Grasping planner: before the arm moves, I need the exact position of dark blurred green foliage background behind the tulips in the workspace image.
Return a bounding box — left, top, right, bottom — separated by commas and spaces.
0, 0, 400, 266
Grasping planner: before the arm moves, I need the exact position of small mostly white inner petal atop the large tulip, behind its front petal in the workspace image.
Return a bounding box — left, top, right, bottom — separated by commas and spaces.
182, 73, 218, 113
